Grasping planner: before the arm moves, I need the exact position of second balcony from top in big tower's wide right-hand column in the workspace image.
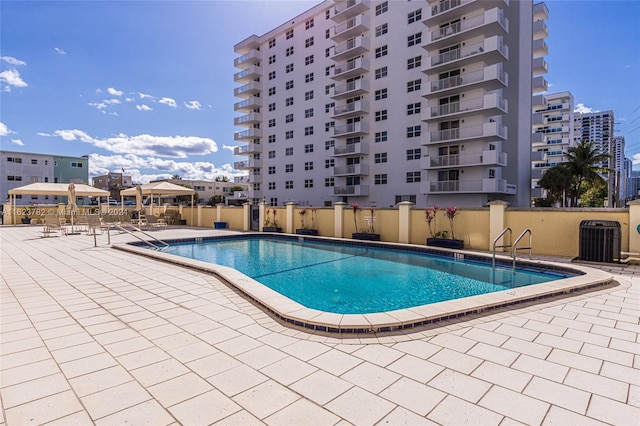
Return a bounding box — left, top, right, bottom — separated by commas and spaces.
425, 7, 509, 50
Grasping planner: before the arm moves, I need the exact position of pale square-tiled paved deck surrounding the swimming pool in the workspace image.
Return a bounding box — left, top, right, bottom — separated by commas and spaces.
0, 226, 640, 425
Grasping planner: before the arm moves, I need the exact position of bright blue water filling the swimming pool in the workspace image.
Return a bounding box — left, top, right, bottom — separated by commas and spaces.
162, 238, 567, 314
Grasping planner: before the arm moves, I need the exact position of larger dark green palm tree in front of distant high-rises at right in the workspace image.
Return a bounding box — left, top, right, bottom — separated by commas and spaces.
564, 140, 610, 206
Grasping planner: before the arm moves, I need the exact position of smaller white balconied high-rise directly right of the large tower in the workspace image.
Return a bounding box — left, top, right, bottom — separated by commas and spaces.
531, 92, 576, 198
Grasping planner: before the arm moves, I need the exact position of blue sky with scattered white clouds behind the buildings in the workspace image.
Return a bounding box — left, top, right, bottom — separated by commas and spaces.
0, 0, 640, 182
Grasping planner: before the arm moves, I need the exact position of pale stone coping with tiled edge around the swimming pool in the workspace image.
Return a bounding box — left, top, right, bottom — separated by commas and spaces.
112, 233, 613, 333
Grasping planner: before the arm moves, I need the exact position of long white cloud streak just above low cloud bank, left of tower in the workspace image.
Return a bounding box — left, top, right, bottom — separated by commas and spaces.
49, 129, 218, 158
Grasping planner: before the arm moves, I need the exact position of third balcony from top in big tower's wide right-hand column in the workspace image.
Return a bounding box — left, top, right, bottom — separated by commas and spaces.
423, 36, 509, 72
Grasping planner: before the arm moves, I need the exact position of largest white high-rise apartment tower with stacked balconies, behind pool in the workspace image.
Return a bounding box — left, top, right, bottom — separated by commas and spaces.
235, 0, 548, 207
